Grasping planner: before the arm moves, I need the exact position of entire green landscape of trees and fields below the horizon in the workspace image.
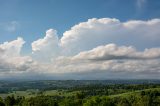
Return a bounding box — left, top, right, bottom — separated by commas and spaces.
0, 80, 160, 106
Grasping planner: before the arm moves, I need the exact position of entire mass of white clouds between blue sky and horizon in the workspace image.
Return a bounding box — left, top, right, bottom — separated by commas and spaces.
0, 18, 160, 79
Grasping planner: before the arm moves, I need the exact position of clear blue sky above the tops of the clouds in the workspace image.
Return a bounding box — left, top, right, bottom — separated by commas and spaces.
0, 0, 160, 52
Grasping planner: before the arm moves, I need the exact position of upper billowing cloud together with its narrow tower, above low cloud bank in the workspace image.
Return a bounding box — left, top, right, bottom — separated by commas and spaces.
32, 18, 160, 58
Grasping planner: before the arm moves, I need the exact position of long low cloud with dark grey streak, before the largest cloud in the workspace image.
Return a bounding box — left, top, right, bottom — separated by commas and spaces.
55, 44, 160, 72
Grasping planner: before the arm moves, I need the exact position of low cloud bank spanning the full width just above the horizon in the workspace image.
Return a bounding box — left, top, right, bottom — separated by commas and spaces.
0, 41, 160, 79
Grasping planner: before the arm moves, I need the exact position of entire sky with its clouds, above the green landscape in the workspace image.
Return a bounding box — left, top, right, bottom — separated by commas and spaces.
0, 0, 160, 80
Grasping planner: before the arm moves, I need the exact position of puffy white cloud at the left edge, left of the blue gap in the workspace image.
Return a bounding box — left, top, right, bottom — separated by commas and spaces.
0, 37, 33, 74
